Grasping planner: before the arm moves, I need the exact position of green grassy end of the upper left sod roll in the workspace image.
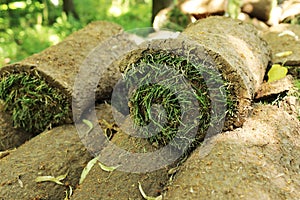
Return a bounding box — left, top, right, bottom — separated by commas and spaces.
0, 71, 70, 134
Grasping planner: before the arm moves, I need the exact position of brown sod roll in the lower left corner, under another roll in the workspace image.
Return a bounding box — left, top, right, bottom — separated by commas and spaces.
0, 125, 91, 200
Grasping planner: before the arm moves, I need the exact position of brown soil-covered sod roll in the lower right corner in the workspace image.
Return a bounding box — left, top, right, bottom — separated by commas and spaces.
164, 105, 300, 200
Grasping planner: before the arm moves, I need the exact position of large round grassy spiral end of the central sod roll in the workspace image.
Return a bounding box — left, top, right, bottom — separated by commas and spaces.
118, 50, 236, 151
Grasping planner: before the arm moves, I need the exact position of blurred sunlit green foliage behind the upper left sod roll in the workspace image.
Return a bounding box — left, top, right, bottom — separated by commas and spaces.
0, 0, 152, 67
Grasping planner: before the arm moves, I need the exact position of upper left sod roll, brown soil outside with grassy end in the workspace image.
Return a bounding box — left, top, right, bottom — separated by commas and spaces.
0, 21, 136, 134
